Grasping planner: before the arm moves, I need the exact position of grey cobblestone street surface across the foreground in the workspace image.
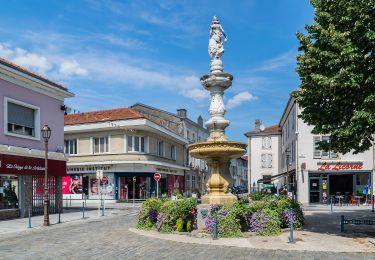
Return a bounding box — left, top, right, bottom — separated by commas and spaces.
0, 212, 375, 260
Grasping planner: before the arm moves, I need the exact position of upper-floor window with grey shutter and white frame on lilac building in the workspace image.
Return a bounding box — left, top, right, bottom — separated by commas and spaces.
4, 98, 40, 139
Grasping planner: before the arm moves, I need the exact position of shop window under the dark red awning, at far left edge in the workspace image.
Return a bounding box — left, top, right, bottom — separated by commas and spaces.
0, 176, 18, 210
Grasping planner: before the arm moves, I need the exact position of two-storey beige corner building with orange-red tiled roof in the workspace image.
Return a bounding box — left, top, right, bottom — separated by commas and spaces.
63, 108, 189, 200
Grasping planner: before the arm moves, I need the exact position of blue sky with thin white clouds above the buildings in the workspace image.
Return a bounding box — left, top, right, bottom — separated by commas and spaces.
0, 0, 313, 141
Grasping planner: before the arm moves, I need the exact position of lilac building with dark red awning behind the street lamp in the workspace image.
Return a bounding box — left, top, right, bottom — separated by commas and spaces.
0, 58, 73, 219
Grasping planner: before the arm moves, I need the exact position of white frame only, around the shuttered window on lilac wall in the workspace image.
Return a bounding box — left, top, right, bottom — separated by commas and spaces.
4, 97, 40, 141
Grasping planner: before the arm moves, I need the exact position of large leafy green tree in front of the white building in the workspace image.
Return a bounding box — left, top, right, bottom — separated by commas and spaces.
292, 0, 375, 153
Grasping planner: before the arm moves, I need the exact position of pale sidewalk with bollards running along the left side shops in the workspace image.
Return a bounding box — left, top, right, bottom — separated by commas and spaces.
0, 201, 141, 236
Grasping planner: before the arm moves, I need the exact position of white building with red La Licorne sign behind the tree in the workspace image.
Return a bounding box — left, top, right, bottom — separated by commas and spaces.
279, 97, 374, 204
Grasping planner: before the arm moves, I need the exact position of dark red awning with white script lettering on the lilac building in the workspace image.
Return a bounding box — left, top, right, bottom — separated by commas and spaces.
0, 154, 66, 176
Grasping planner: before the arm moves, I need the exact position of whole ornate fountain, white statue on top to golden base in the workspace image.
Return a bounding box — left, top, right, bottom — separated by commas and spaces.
189, 16, 246, 204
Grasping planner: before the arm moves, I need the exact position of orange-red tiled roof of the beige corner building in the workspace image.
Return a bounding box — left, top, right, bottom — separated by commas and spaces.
64, 108, 144, 125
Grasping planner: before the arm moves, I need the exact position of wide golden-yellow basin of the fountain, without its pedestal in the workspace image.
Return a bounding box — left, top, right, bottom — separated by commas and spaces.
189, 141, 247, 159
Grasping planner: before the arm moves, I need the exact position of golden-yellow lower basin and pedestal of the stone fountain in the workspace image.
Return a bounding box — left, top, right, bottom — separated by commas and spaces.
189, 141, 246, 205
